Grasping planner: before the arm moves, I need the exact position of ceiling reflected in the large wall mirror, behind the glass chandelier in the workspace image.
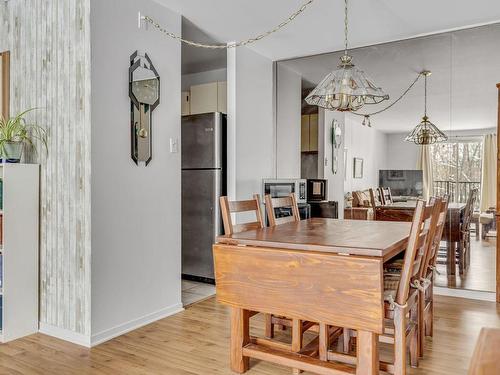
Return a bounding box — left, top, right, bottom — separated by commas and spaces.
278, 23, 500, 133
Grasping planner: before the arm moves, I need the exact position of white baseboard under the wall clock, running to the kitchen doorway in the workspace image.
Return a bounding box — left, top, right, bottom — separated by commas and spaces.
90, 303, 184, 347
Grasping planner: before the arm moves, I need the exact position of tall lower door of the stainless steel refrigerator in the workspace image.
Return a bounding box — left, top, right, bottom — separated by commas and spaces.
182, 170, 222, 279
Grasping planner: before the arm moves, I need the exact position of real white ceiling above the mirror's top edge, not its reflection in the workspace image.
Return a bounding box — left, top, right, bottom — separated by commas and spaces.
156, 0, 500, 60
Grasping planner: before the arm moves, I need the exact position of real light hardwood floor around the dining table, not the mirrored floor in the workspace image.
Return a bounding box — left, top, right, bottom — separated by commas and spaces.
0, 296, 500, 375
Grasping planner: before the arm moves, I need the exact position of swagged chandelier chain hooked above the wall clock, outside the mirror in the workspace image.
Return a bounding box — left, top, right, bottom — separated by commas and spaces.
144, 0, 314, 49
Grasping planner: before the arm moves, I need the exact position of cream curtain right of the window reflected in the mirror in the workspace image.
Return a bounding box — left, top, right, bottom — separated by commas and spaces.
480, 134, 497, 212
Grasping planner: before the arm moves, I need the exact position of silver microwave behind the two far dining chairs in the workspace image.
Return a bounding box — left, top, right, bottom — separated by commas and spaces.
262, 179, 311, 224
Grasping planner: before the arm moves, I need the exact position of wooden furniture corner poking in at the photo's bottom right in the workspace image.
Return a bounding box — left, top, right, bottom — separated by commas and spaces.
469, 328, 500, 375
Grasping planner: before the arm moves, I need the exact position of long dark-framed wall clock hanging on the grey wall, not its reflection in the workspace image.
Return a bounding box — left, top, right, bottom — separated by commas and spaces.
129, 51, 160, 165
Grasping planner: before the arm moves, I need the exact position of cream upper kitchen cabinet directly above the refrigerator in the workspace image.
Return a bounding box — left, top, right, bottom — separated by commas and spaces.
189, 82, 227, 115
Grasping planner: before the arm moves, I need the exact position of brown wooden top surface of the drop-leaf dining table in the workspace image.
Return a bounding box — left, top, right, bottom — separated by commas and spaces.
217, 218, 411, 259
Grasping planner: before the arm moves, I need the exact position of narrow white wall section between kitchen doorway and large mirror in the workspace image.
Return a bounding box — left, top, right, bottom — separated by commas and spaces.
227, 47, 275, 200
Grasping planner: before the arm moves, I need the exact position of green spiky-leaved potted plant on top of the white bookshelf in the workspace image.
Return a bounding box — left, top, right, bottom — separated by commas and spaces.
0, 109, 47, 163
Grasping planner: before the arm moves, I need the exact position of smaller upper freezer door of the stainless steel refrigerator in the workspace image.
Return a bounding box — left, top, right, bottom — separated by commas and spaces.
181, 112, 225, 169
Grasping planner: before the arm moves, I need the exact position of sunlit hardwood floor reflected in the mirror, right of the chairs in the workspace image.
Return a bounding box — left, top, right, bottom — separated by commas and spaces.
436, 234, 496, 292
